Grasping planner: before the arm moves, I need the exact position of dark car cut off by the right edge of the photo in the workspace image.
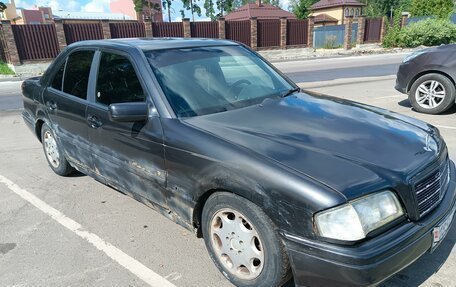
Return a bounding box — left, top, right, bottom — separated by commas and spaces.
396, 44, 456, 114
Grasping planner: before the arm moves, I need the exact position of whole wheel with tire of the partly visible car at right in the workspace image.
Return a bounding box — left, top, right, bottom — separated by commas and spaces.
409, 73, 456, 114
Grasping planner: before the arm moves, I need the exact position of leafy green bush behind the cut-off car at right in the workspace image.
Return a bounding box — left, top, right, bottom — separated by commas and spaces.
383, 18, 456, 48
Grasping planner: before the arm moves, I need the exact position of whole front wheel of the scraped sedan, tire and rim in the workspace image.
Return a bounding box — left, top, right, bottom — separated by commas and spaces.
202, 192, 292, 287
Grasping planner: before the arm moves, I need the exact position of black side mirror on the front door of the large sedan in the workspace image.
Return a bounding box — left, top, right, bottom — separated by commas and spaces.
109, 102, 149, 122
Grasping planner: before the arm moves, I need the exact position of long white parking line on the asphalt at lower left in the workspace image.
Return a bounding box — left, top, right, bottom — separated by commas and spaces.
0, 175, 175, 287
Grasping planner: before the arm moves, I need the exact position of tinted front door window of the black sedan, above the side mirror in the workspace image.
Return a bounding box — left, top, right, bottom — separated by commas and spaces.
95, 53, 146, 106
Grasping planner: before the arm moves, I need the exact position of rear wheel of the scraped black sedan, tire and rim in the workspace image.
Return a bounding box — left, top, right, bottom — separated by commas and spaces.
41, 124, 74, 176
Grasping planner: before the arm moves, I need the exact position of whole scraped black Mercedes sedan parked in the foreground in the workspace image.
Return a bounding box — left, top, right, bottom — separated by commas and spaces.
22, 39, 456, 287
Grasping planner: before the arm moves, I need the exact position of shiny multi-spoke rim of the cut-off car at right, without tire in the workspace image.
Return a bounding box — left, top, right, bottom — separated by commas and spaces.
415, 80, 446, 109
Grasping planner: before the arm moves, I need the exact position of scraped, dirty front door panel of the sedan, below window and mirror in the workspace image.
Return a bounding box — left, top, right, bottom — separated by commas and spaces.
87, 105, 167, 207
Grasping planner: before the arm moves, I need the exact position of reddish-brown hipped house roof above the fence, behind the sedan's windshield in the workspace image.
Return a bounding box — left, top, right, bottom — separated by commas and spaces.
225, 3, 296, 21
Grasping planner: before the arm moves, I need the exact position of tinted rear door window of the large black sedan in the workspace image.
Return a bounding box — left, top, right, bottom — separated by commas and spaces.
63, 51, 95, 100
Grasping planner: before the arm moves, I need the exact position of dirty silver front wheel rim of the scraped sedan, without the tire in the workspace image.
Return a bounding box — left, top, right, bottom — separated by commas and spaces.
210, 208, 264, 280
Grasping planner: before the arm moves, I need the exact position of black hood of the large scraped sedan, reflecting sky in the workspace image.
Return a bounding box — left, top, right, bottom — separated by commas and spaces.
183, 93, 439, 199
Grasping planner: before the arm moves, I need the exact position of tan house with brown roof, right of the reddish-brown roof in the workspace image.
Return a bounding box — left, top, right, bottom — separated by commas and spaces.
310, 0, 366, 25
